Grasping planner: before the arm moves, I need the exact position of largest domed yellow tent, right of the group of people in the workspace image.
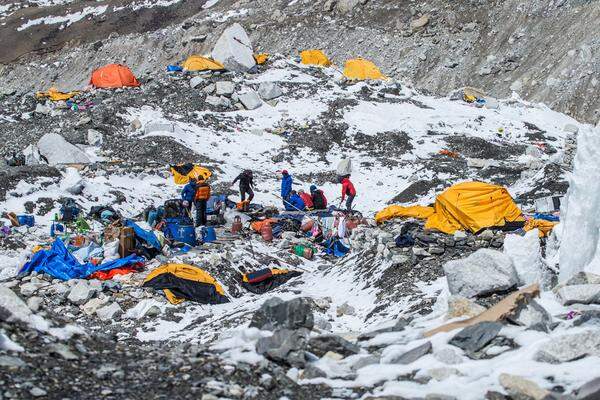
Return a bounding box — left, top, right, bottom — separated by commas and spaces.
425, 182, 525, 234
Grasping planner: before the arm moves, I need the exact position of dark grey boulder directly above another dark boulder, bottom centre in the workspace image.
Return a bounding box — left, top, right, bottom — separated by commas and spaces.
250, 297, 314, 330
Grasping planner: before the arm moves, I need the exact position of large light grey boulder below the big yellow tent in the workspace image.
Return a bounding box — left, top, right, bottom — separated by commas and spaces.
444, 249, 519, 297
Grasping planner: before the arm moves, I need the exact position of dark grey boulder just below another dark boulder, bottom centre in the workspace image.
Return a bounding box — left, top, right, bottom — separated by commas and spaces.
256, 328, 310, 368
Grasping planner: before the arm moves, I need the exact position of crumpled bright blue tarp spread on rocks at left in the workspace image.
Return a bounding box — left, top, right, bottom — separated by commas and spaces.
19, 238, 144, 281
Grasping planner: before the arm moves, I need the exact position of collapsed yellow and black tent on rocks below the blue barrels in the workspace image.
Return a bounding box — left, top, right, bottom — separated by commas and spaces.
142, 264, 229, 304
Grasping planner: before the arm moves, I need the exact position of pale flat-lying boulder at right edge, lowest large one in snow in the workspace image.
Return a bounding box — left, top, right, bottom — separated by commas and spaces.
534, 330, 600, 364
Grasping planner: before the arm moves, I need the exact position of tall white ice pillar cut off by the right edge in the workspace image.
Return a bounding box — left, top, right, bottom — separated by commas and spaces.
559, 129, 600, 282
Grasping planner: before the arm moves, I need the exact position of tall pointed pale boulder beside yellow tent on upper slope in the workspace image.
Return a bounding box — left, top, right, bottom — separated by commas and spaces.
211, 23, 256, 72
